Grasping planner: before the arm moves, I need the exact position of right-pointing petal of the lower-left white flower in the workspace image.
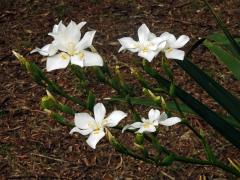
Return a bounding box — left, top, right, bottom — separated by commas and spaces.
106, 111, 127, 127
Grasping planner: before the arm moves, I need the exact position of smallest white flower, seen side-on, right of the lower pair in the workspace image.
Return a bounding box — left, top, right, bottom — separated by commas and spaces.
122, 109, 181, 133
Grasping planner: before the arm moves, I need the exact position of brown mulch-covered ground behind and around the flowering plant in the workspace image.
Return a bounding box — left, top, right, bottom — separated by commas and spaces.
0, 0, 240, 179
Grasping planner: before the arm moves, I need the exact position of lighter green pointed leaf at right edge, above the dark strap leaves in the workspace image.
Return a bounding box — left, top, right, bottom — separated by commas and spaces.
204, 41, 240, 80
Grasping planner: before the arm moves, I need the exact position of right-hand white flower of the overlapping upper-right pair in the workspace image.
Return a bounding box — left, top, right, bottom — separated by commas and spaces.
159, 32, 190, 60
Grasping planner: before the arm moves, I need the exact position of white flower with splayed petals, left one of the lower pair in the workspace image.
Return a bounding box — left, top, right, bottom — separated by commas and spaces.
70, 103, 127, 149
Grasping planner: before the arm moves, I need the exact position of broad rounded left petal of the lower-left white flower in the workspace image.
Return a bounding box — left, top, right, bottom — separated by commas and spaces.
74, 113, 96, 129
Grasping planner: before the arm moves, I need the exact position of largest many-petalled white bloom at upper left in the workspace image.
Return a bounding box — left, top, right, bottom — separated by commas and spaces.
31, 21, 103, 71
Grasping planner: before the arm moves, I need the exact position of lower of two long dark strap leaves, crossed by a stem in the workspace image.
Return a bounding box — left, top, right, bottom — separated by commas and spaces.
143, 61, 240, 148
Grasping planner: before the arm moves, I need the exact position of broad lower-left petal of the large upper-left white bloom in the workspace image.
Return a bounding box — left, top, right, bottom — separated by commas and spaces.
47, 53, 70, 72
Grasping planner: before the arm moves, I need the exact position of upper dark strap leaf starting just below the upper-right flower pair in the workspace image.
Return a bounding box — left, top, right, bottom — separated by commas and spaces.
176, 58, 240, 121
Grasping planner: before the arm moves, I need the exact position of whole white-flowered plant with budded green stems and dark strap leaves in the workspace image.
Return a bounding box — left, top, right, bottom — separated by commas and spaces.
14, 1, 240, 176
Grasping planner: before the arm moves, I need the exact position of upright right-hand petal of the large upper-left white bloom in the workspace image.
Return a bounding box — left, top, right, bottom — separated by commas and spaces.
76, 31, 96, 51
